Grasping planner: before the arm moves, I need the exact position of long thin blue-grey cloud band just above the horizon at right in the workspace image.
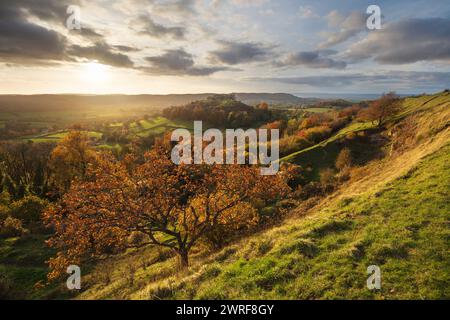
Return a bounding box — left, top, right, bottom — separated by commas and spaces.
246, 71, 450, 90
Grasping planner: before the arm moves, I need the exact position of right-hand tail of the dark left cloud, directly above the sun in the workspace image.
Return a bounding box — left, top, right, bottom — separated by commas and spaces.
68, 42, 133, 68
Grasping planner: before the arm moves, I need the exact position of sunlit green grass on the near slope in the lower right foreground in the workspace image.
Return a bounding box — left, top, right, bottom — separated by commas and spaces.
136, 146, 450, 299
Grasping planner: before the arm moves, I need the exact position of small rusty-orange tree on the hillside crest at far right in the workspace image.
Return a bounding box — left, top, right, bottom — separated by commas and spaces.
359, 92, 400, 127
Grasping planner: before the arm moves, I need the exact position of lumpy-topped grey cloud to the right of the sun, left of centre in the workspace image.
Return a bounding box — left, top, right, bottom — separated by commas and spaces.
141, 49, 229, 76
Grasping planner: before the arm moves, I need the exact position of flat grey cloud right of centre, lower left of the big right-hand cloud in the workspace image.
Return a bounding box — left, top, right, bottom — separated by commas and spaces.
275, 50, 347, 69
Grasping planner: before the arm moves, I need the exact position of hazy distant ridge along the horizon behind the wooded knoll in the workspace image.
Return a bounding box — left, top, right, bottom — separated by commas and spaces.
0, 93, 317, 112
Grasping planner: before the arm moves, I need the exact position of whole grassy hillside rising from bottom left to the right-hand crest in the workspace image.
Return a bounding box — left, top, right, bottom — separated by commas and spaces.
69, 93, 450, 299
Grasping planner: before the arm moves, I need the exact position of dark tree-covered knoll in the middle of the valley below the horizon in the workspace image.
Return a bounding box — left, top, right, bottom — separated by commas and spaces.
163, 94, 278, 128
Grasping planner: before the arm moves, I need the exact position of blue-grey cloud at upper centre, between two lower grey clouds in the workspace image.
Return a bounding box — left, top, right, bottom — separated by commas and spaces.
210, 41, 273, 65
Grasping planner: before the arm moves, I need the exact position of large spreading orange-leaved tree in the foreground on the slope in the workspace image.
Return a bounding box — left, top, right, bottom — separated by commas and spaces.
44, 145, 289, 278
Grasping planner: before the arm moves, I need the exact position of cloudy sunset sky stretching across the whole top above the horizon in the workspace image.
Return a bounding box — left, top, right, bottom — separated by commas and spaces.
0, 0, 450, 95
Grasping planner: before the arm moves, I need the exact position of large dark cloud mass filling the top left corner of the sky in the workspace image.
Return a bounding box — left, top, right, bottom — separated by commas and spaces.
0, 0, 133, 68
